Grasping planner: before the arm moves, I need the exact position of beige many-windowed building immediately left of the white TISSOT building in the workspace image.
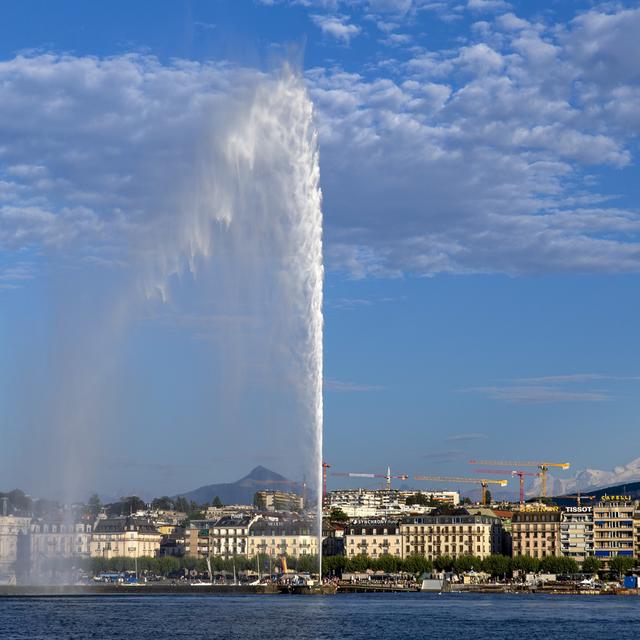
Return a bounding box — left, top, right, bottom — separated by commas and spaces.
511, 510, 560, 558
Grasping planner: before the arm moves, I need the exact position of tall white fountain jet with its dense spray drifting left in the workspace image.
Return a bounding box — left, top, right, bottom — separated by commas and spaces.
146, 68, 324, 576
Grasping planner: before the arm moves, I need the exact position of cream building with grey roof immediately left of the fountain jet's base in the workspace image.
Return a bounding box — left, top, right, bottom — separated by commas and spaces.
248, 517, 318, 558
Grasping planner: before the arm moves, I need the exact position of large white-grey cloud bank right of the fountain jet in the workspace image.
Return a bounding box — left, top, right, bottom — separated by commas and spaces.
308, 4, 640, 277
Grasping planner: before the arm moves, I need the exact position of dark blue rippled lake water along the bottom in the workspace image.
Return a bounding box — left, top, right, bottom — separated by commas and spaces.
0, 593, 640, 640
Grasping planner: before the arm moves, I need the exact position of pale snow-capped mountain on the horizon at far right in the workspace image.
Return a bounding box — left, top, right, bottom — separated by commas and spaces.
527, 458, 640, 497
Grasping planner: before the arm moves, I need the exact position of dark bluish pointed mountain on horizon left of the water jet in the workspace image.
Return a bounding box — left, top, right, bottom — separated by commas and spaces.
173, 466, 300, 504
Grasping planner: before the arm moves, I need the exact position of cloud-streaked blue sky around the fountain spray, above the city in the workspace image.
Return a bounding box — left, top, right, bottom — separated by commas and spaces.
0, 0, 640, 500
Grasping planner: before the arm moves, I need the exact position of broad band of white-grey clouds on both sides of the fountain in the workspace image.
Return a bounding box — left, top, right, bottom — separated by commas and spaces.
0, 5, 640, 284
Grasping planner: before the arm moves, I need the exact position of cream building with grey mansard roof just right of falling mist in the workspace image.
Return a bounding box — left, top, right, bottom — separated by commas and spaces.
91, 516, 161, 558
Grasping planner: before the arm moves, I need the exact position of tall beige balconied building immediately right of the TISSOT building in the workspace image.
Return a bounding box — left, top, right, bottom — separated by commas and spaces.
593, 495, 635, 566
